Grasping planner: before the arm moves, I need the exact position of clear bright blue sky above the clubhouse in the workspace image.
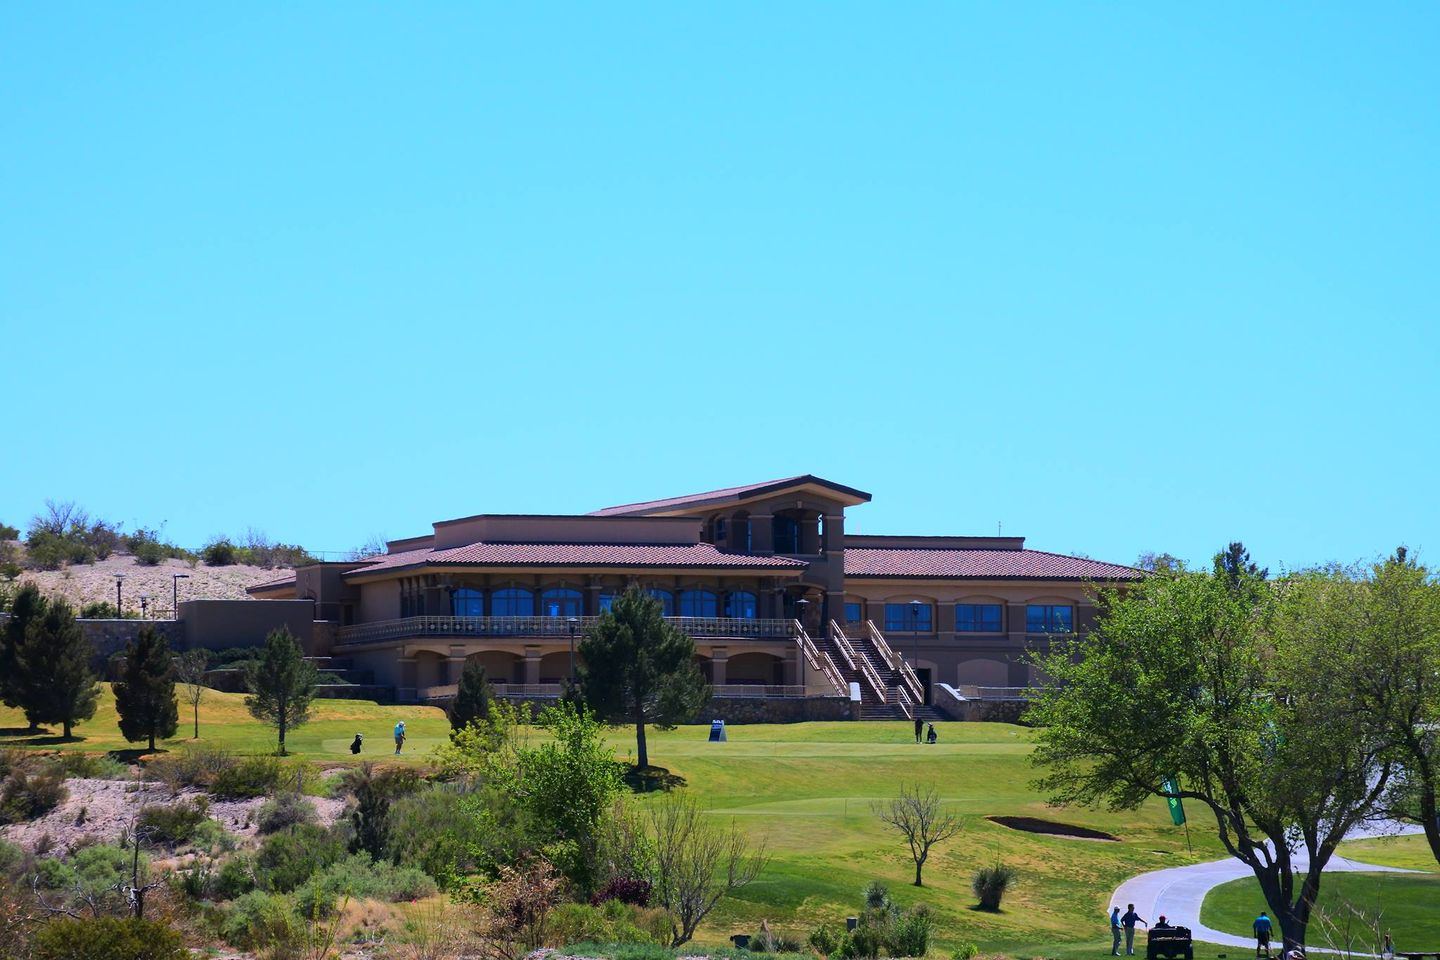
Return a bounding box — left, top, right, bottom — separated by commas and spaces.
0, 3, 1440, 566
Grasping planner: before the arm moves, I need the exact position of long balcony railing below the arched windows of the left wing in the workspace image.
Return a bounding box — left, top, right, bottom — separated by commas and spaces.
340, 616, 795, 643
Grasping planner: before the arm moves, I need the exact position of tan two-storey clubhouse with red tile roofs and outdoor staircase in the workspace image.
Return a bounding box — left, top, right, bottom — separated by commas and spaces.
249, 475, 1142, 717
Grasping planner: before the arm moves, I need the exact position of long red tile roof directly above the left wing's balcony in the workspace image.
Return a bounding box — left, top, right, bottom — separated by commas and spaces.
342, 543, 805, 576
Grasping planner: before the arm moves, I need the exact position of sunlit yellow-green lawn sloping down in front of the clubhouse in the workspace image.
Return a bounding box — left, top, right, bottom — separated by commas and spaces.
0, 688, 1223, 960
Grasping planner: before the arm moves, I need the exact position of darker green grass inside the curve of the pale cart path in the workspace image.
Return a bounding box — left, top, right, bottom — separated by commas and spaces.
1200, 874, 1440, 953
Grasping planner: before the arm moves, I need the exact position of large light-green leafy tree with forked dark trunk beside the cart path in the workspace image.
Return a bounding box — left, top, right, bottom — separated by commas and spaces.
1031, 544, 1392, 946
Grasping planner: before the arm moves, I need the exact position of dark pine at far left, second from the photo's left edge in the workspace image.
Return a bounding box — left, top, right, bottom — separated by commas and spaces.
16, 600, 99, 740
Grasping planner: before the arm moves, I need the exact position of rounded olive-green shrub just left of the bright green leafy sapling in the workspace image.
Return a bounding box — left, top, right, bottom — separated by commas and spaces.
384, 784, 487, 888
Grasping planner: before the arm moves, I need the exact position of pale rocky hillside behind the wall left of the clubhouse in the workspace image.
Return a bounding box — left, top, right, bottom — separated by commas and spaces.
19, 556, 291, 612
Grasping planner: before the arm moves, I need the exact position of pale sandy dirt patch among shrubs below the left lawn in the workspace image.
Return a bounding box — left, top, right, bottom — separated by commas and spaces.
0, 777, 346, 851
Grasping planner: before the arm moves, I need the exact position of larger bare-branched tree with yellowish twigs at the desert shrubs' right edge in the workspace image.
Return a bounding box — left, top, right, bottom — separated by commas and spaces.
648, 797, 769, 947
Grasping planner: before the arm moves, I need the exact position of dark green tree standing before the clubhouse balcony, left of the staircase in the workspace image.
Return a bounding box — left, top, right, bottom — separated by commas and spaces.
579, 587, 710, 769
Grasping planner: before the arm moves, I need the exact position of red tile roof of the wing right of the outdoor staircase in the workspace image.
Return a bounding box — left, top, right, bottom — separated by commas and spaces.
845, 547, 1145, 580
